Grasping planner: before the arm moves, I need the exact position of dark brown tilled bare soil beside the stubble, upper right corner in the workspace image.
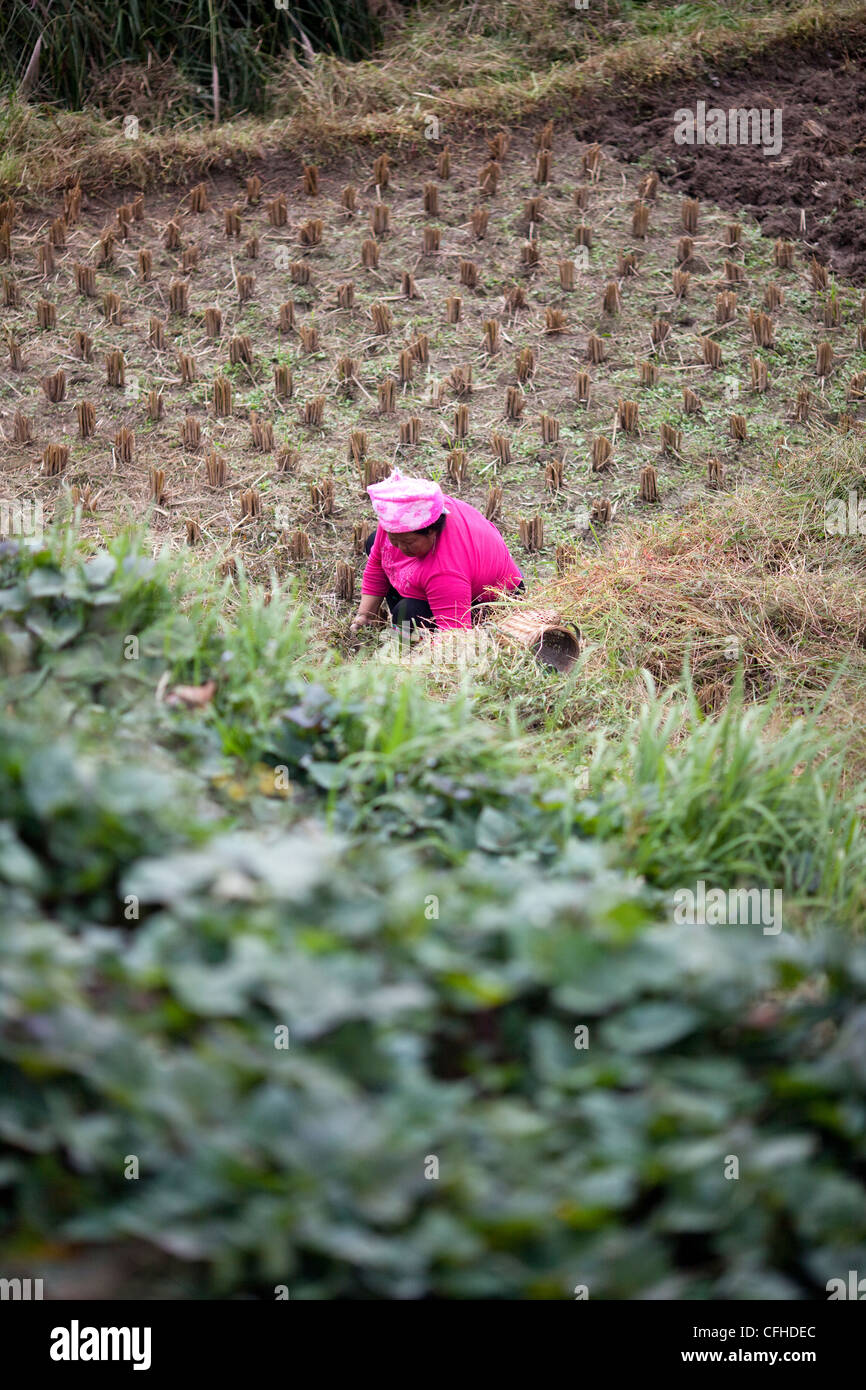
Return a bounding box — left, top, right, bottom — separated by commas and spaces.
575, 54, 866, 284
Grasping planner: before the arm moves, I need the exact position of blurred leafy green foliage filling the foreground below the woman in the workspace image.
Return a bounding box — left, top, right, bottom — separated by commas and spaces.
0, 541, 866, 1298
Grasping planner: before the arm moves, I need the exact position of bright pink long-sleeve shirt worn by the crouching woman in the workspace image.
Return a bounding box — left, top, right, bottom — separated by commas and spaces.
361, 498, 523, 628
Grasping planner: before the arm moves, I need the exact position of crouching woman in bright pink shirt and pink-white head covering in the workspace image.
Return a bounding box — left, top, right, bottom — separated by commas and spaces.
352, 468, 524, 630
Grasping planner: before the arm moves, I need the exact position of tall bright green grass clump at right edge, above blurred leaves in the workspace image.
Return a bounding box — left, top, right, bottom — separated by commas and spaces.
584, 678, 866, 922
